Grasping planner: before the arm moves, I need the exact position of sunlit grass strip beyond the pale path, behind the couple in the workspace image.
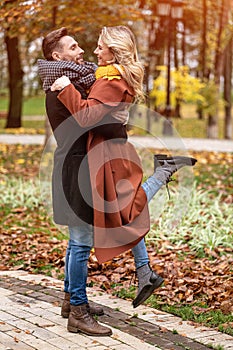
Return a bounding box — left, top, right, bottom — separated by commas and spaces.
0, 94, 233, 139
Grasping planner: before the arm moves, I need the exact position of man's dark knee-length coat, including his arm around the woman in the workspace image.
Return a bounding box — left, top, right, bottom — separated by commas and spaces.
46, 88, 127, 226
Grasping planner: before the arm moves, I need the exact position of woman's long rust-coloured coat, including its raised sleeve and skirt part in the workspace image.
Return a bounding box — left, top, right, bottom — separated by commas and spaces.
58, 79, 150, 263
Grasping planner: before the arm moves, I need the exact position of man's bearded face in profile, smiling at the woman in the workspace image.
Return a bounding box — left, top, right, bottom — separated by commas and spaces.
52, 35, 84, 64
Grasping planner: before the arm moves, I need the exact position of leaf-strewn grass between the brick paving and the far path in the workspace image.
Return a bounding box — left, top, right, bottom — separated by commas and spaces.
0, 145, 233, 335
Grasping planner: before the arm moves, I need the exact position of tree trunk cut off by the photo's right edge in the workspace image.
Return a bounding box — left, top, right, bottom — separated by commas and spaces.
224, 38, 233, 140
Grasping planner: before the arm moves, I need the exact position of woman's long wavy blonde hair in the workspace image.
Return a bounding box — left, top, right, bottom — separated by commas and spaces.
100, 26, 145, 101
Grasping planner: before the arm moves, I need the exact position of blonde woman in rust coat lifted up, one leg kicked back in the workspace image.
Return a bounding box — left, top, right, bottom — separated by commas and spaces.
51, 26, 197, 320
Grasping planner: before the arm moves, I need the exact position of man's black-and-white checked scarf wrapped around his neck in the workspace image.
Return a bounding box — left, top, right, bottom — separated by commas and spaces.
37, 59, 97, 91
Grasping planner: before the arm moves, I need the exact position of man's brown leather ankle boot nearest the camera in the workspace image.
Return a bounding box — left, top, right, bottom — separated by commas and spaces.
67, 304, 112, 336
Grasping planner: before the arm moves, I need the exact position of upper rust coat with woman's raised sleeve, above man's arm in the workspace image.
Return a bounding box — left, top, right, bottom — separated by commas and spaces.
58, 79, 131, 128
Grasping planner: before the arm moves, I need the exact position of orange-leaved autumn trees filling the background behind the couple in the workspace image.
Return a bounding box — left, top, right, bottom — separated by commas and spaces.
0, 0, 233, 139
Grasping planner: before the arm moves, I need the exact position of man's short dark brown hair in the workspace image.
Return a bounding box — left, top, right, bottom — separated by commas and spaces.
42, 27, 68, 61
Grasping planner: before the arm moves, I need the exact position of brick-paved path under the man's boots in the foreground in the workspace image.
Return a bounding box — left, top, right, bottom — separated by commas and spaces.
0, 271, 233, 350
